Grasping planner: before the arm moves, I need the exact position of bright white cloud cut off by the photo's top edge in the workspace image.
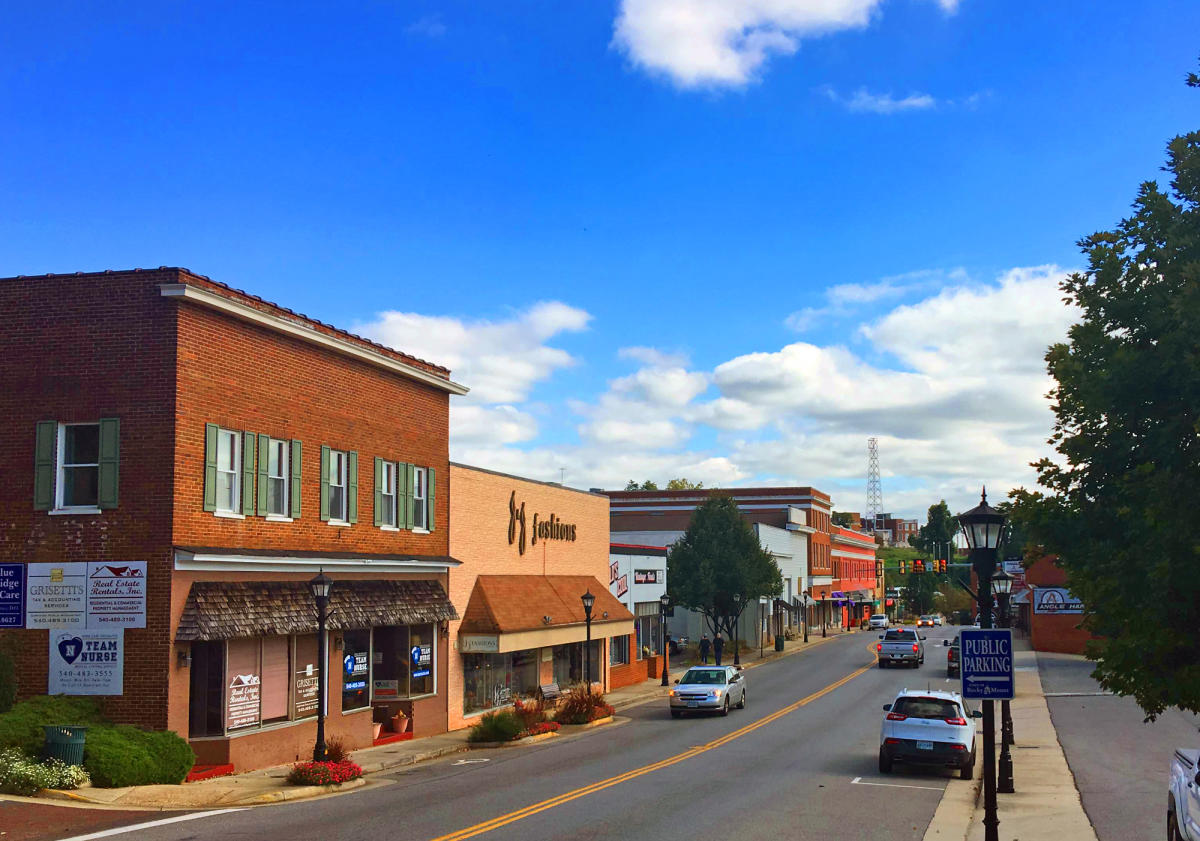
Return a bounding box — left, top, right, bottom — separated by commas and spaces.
613, 0, 958, 88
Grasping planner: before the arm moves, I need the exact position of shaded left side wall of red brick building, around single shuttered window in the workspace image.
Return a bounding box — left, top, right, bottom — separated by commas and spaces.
0, 271, 175, 728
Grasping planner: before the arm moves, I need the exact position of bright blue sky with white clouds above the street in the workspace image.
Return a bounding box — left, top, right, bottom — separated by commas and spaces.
0, 0, 1200, 516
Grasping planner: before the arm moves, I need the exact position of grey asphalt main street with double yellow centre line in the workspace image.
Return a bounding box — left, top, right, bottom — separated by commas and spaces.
46, 627, 968, 841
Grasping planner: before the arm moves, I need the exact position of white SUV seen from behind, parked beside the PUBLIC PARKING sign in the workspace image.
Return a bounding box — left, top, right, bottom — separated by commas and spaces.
880, 689, 983, 780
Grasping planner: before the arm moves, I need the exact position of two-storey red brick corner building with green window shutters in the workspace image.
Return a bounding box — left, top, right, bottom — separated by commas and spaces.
0, 268, 463, 770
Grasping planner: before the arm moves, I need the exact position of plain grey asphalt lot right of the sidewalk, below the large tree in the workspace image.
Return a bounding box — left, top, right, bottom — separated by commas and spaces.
1041, 653, 1200, 841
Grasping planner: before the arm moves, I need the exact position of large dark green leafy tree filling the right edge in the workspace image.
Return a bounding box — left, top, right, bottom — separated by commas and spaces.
1012, 67, 1200, 720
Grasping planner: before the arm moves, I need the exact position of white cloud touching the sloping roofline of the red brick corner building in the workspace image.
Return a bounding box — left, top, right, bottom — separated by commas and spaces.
353, 301, 592, 403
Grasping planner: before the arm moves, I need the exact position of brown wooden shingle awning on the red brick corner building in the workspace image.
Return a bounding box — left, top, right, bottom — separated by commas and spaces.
175, 581, 458, 642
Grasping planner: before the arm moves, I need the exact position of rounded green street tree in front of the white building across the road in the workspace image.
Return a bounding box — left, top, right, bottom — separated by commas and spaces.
667, 495, 784, 637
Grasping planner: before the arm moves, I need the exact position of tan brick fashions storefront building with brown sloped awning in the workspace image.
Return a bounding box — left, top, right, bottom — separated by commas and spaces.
448, 463, 646, 729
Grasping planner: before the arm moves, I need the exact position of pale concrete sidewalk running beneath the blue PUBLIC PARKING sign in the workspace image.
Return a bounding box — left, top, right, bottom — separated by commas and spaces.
925, 639, 1096, 841
